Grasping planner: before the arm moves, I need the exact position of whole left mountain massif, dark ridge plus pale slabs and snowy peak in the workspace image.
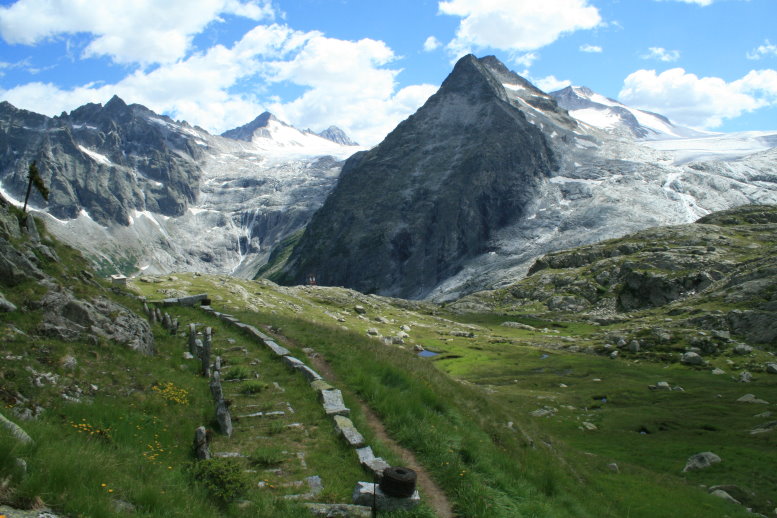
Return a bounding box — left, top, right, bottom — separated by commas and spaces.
0, 97, 358, 276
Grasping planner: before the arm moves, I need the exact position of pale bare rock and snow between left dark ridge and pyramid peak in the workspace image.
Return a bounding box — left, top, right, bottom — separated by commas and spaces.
36, 114, 363, 277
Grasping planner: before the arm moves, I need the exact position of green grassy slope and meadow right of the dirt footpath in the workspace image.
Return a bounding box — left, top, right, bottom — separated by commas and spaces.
129, 275, 777, 517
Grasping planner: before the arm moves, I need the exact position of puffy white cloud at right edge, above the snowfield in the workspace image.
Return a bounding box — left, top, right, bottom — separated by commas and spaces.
619, 68, 777, 128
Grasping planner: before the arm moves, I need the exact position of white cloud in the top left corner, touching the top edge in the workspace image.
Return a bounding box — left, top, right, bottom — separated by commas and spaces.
0, 0, 275, 65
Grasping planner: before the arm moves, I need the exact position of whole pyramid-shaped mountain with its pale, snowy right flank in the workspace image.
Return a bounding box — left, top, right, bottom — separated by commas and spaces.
271, 55, 777, 300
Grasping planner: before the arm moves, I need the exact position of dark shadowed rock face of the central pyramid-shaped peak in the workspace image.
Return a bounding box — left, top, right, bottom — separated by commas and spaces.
279, 55, 560, 297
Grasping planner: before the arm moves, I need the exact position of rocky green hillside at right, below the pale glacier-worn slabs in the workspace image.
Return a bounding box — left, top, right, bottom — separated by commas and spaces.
451, 205, 777, 350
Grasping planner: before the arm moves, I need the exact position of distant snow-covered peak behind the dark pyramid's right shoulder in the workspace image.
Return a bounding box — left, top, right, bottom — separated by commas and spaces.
550, 86, 713, 139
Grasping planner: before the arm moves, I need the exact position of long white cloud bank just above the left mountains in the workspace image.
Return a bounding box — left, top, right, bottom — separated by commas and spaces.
0, 24, 437, 145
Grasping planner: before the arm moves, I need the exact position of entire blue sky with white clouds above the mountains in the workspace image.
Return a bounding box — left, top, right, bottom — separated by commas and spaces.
0, 0, 777, 146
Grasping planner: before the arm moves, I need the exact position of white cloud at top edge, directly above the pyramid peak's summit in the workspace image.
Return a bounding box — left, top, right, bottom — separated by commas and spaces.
438, 0, 602, 56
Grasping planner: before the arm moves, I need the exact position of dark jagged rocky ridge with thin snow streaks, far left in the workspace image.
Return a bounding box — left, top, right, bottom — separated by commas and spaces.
0, 96, 202, 225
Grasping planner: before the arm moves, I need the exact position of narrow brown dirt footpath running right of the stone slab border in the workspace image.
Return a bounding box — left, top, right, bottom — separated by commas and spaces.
284, 337, 456, 518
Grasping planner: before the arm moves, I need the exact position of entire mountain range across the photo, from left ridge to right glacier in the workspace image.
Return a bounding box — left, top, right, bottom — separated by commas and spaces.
0, 55, 777, 300
